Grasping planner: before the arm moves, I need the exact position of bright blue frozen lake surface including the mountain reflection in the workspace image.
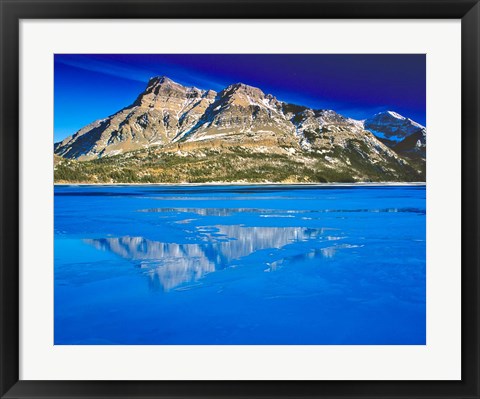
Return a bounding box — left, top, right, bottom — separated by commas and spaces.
54, 185, 426, 345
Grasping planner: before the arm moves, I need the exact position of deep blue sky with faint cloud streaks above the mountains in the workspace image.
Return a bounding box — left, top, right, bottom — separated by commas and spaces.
55, 54, 426, 141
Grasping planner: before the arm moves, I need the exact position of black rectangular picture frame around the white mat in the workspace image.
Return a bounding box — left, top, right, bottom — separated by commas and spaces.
0, 0, 480, 399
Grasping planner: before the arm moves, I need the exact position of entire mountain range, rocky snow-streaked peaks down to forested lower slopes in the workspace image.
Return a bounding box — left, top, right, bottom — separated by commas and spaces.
54, 76, 426, 182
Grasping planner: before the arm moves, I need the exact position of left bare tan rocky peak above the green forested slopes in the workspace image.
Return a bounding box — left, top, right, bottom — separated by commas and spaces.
55, 76, 217, 160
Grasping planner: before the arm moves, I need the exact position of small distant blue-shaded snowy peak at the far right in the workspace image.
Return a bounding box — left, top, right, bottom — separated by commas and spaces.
364, 111, 425, 146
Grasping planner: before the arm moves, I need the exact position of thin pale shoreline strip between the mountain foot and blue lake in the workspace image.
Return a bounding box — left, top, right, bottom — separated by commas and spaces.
53, 182, 427, 187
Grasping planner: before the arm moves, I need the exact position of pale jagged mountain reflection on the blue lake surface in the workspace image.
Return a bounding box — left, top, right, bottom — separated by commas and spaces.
84, 225, 334, 291
